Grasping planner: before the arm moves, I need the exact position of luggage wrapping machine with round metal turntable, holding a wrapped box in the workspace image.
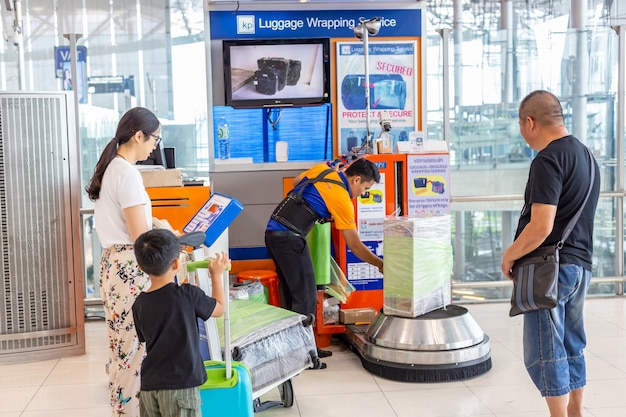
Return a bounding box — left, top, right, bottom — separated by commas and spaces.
335, 153, 491, 382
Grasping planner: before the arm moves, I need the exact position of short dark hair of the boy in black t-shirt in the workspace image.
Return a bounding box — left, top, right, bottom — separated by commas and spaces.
134, 229, 180, 276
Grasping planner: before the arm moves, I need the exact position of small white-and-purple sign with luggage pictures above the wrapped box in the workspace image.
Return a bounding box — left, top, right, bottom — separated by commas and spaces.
407, 153, 450, 217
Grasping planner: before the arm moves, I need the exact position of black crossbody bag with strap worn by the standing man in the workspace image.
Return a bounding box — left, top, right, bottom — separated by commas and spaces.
509, 148, 595, 317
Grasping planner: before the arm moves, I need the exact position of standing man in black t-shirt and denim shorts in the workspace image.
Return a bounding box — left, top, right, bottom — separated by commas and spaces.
502, 90, 600, 417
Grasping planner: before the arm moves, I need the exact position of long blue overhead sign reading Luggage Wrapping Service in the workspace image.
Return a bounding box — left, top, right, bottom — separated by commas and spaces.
209, 9, 422, 39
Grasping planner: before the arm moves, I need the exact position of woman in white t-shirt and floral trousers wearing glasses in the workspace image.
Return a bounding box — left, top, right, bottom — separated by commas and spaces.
86, 107, 161, 417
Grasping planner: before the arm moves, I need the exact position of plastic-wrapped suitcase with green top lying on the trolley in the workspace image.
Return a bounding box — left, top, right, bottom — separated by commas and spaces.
218, 300, 319, 398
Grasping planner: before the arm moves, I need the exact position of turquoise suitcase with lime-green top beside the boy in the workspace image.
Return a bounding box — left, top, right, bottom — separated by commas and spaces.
200, 361, 254, 417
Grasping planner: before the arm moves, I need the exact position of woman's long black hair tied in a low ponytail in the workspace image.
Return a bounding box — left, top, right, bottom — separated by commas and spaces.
85, 107, 160, 201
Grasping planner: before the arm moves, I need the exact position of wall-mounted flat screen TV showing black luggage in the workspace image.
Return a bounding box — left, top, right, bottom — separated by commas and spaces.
222, 38, 330, 108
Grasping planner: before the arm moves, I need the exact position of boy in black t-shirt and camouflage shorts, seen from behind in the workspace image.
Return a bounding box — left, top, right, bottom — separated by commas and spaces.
133, 229, 230, 417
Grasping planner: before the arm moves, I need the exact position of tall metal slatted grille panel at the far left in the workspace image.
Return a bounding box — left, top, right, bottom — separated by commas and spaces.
0, 93, 82, 356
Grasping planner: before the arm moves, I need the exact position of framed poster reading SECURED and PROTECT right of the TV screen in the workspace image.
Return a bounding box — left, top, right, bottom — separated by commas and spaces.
336, 39, 418, 154
